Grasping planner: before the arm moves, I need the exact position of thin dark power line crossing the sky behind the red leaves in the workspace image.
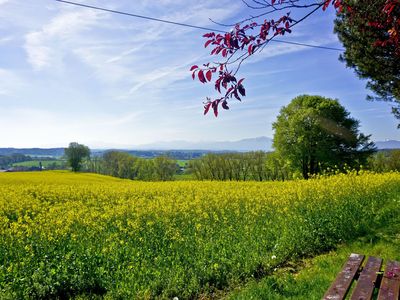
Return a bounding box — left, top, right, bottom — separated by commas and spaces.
54, 0, 344, 52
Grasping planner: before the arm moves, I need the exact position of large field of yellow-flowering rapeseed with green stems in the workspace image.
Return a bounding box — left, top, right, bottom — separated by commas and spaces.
0, 172, 400, 299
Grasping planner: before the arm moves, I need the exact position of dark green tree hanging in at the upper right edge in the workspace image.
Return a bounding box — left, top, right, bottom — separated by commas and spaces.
335, 0, 400, 122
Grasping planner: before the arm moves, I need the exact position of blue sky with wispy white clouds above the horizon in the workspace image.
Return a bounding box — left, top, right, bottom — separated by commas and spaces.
0, 0, 400, 148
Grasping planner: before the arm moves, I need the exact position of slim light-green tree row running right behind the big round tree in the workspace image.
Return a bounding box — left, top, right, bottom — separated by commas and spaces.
187, 150, 400, 181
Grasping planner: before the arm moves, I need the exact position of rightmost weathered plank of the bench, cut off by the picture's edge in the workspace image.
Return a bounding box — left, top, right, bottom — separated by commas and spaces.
378, 261, 400, 300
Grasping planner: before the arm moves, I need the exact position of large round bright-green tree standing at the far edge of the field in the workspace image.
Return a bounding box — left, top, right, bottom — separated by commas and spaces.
273, 95, 375, 179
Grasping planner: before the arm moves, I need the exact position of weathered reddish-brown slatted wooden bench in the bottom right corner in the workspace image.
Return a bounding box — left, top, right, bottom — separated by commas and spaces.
323, 254, 400, 300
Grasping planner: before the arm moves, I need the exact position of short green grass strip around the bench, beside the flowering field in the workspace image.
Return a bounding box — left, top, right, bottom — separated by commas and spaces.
225, 210, 400, 300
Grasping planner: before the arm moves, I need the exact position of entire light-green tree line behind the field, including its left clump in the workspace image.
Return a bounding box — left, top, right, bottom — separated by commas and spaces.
64, 144, 400, 181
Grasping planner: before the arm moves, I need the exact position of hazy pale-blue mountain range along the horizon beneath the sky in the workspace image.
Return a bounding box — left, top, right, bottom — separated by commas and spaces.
0, 136, 400, 157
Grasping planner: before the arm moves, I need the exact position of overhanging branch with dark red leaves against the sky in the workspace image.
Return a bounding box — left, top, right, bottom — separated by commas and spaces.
190, 0, 400, 117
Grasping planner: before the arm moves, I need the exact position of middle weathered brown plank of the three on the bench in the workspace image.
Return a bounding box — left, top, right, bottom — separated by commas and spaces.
351, 256, 382, 300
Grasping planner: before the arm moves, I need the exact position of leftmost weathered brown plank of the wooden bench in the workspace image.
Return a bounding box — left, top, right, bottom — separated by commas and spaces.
323, 253, 366, 300
